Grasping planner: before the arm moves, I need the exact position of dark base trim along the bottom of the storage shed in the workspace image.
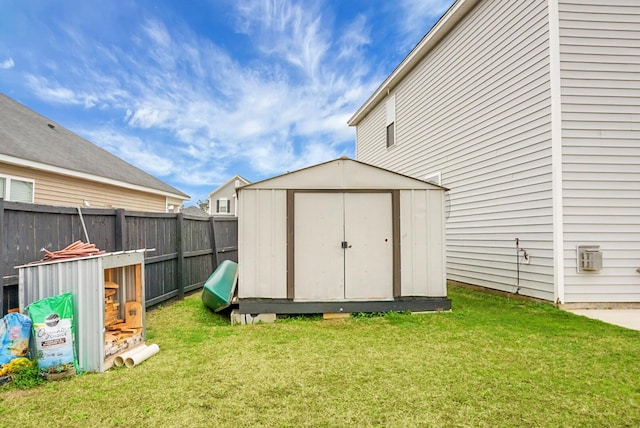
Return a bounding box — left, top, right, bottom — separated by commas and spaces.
238, 297, 451, 314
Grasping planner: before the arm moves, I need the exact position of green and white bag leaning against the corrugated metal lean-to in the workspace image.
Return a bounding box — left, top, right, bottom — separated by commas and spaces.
26, 293, 78, 379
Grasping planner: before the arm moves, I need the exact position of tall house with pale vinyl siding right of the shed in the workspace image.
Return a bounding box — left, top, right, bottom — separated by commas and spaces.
349, 0, 640, 307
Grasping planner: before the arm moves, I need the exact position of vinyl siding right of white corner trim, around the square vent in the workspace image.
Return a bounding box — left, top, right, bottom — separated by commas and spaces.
559, 0, 640, 303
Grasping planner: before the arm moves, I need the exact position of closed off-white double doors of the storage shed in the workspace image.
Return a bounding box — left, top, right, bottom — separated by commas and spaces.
294, 192, 393, 301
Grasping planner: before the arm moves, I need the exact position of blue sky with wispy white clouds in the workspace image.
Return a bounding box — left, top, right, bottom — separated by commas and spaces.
0, 0, 453, 205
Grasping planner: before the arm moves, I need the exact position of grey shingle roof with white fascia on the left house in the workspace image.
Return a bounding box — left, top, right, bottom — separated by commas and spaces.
0, 93, 190, 200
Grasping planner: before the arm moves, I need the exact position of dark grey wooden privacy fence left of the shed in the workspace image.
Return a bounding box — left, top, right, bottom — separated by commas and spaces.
0, 199, 238, 315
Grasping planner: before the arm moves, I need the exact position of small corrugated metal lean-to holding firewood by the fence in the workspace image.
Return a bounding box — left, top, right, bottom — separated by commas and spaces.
16, 250, 145, 372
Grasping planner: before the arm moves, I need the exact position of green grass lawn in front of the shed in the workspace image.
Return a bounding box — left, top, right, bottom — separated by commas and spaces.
0, 287, 640, 427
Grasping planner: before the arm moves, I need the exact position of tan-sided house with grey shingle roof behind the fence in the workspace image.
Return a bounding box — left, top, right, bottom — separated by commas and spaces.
0, 94, 189, 212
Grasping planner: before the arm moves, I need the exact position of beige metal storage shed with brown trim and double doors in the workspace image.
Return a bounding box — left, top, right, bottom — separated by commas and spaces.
238, 157, 451, 314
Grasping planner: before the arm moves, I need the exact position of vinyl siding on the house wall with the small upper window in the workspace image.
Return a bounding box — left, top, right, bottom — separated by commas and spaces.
356, 0, 554, 300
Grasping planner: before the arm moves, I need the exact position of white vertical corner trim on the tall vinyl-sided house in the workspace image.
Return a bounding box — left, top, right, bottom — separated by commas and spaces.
547, 0, 565, 304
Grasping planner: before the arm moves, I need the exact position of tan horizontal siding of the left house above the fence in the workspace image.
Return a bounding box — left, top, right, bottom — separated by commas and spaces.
0, 164, 167, 212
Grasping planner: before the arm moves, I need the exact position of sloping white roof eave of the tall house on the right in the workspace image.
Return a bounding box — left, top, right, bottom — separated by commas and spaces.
347, 0, 480, 126
